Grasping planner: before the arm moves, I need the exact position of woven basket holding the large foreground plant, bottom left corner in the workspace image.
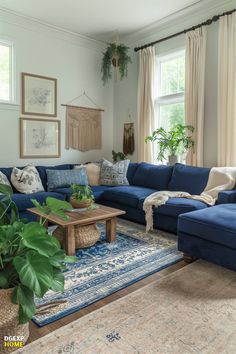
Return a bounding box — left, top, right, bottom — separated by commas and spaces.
0, 289, 29, 354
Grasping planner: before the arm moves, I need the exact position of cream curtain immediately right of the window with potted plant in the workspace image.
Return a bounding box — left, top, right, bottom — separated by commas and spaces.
185, 26, 206, 166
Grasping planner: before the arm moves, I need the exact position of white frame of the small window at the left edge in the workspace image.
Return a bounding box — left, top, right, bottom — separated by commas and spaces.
0, 37, 16, 104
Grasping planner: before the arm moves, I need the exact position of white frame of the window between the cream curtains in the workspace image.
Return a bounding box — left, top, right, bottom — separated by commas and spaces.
154, 47, 185, 128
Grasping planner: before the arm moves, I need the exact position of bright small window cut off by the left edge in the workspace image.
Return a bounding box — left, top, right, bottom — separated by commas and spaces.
0, 39, 15, 103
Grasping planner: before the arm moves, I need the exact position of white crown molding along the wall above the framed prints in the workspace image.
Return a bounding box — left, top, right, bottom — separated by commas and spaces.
0, 7, 106, 51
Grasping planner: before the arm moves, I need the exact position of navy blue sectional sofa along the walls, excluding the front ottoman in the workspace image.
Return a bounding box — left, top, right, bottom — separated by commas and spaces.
0, 163, 236, 233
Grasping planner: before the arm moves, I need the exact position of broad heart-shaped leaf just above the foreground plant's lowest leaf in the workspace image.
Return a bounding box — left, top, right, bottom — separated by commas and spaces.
13, 251, 53, 297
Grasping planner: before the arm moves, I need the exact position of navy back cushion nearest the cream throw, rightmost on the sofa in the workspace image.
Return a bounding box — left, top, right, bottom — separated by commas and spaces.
168, 163, 210, 195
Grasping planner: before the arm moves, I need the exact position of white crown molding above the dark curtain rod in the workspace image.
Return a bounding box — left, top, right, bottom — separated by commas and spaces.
121, 0, 235, 47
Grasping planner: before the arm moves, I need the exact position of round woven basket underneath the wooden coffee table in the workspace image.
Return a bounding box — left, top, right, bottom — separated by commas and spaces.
75, 224, 100, 249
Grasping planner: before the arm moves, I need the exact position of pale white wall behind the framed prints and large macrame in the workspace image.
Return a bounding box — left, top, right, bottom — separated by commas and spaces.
0, 12, 113, 166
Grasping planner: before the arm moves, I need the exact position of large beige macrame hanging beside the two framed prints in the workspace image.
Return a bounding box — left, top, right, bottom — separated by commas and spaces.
62, 91, 104, 151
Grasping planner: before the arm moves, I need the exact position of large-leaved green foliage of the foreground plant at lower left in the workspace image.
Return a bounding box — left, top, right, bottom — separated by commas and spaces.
0, 184, 75, 323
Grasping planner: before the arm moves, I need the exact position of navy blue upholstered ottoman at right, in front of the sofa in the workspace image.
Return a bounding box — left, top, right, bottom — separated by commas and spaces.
178, 204, 236, 271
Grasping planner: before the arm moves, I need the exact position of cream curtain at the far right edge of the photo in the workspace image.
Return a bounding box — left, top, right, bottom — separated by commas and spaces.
218, 13, 236, 166
